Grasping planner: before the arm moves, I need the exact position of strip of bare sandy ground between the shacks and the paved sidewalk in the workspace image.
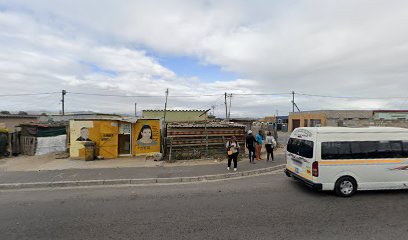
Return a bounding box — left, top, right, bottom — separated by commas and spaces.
0, 148, 283, 172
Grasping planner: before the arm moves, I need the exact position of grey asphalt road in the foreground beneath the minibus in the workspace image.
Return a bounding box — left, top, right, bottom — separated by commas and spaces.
0, 173, 408, 240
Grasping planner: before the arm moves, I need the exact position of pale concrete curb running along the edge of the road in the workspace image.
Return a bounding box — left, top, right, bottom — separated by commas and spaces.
0, 164, 285, 190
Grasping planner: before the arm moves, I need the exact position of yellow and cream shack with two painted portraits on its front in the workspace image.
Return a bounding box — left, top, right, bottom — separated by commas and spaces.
69, 118, 161, 159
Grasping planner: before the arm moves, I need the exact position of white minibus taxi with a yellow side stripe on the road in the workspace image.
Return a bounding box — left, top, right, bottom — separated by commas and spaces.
285, 127, 408, 197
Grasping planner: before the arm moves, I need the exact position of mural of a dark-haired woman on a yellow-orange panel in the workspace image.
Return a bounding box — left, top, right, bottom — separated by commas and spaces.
132, 119, 160, 155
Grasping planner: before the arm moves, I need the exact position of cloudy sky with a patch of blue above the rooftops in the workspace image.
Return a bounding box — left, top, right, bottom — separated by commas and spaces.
0, 0, 408, 117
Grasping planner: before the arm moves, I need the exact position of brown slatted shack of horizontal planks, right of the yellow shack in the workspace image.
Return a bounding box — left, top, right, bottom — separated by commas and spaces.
166, 122, 245, 160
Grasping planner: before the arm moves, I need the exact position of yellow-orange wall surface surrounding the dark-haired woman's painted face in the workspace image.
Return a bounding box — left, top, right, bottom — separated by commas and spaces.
132, 119, 160, 156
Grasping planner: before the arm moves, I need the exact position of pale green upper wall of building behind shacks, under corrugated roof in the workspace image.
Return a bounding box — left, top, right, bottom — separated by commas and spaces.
143, 110, 207, 122
